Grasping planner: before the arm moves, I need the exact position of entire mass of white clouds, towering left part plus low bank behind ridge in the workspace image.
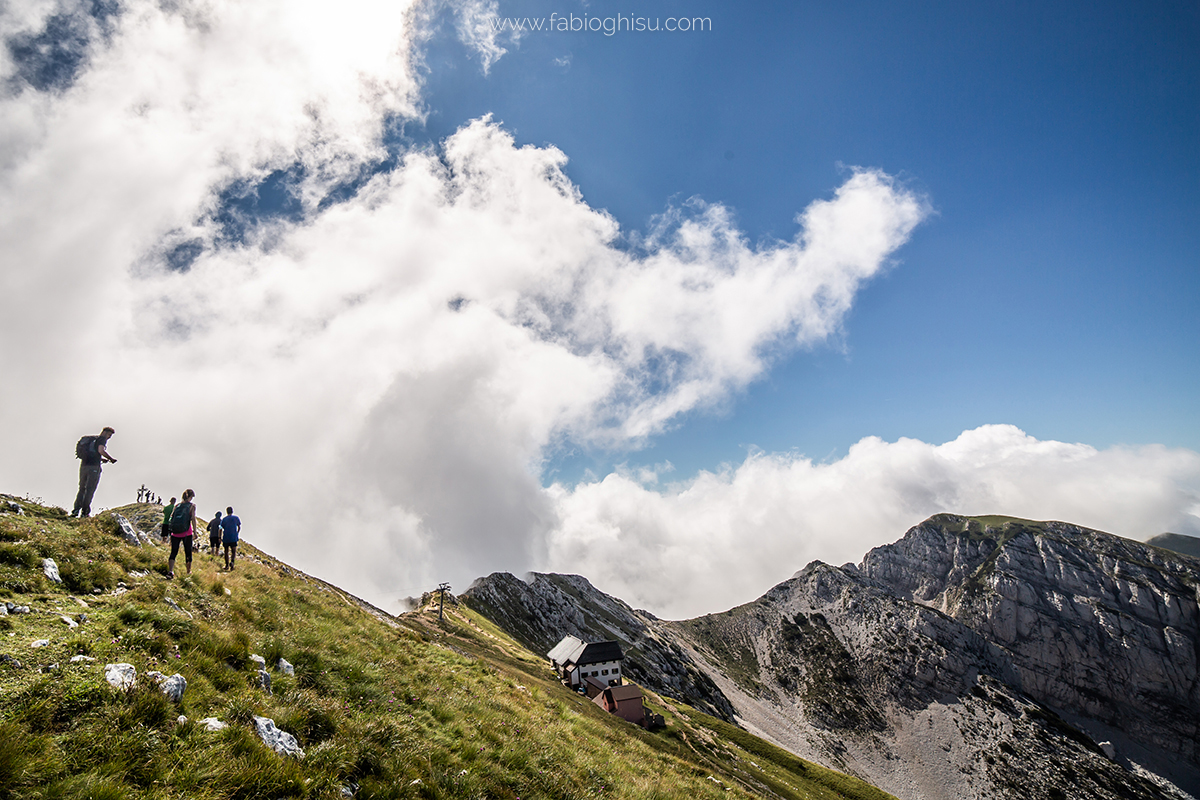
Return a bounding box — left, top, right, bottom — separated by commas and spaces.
0, 0, 1195, 613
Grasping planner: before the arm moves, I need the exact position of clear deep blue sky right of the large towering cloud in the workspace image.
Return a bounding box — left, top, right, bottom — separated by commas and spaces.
414, 2, 1200, 480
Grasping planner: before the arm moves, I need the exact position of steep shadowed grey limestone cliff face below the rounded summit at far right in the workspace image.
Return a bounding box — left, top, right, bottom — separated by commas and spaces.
862, 515, 1200, 794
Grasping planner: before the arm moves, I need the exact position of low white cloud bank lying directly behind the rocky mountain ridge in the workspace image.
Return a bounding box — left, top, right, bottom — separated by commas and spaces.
546, 425, 1200, 618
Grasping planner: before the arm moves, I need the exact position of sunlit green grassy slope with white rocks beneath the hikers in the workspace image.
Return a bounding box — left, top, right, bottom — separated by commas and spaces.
0, 499, 889, 800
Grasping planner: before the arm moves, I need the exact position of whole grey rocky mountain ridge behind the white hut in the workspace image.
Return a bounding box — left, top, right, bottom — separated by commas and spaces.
463, 515, 1200, 800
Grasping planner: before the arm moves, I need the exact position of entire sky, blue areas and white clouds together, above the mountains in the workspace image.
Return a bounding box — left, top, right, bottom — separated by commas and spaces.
0, 0, 1200, 616
